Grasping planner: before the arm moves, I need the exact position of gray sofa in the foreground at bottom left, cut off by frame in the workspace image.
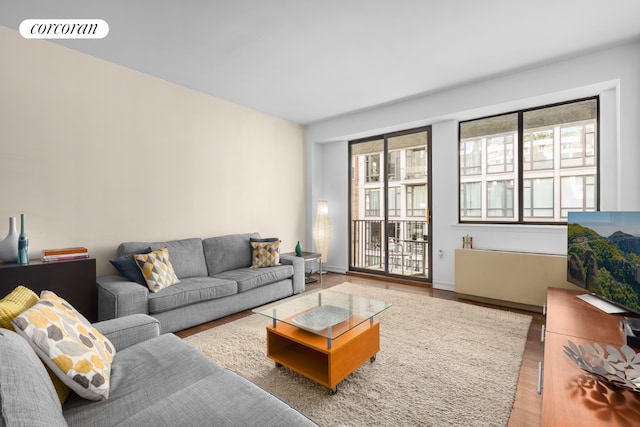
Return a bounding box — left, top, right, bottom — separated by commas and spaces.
0, 315, 316, 427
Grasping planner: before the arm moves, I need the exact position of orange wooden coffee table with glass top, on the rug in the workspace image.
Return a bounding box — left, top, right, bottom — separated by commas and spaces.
254, 290, 391, 393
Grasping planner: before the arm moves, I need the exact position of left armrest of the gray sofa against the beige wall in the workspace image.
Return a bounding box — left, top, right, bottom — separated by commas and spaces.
96, 274, 149, 320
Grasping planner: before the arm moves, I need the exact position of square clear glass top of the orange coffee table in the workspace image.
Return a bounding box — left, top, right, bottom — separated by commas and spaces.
253, 289, 391, 339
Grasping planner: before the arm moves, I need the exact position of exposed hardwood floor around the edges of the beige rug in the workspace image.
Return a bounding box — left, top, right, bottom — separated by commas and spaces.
176, 273, 544, 427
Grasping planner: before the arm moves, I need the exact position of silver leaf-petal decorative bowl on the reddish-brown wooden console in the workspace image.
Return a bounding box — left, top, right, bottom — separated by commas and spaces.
564, 340, 640, 393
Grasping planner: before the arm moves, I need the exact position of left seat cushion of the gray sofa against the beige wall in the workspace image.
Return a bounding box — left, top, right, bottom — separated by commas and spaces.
148, 276, 238, 314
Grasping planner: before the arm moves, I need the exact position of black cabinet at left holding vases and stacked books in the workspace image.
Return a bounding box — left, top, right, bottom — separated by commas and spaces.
0, 258, 98, 322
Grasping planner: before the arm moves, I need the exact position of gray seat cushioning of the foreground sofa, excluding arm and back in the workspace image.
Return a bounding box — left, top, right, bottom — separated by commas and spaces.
63, 334, 314, 427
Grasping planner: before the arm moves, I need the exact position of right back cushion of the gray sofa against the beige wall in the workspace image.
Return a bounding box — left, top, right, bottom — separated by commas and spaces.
202, 233, 260, 276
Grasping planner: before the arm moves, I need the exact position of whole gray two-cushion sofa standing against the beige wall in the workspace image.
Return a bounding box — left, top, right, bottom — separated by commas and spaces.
97, 233, 305, 333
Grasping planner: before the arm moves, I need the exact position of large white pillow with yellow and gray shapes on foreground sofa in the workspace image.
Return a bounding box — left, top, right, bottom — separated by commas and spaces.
12, 291, 115, 400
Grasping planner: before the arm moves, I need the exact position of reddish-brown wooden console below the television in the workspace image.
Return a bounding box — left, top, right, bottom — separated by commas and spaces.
542, 288, 640, 427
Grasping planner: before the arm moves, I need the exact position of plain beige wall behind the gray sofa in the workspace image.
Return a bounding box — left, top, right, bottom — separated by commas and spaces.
0, 26, 306, 274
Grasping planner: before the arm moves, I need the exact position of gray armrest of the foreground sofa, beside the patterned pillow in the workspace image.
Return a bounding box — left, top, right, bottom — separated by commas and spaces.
93, 314, 160, 351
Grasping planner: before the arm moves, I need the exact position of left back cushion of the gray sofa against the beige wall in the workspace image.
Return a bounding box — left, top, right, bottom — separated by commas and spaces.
116, 238, 208, 279
